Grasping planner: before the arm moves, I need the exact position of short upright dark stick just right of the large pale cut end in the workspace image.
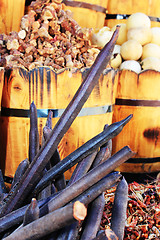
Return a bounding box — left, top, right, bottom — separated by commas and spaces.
80, 193, 105, 240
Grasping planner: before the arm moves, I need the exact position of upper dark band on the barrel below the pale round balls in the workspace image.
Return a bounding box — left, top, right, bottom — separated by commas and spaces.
115, 98, 160, 107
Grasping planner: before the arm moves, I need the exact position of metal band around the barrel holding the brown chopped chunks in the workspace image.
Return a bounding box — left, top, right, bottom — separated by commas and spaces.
1, 105, 113, 118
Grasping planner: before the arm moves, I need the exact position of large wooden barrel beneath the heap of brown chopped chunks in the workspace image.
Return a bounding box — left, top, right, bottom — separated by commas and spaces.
0, 67, 118, 179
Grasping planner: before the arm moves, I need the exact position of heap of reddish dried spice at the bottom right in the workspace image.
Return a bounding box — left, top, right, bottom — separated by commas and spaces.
101, 182, 160, 240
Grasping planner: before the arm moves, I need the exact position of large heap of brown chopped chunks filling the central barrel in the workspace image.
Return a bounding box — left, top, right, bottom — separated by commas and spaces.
0, 0, 99, 71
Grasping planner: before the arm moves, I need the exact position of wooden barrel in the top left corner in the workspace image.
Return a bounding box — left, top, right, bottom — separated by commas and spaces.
0, 0, 25, 34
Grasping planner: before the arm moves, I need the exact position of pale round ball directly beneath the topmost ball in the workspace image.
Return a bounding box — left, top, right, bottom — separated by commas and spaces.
127, 27, 152, 46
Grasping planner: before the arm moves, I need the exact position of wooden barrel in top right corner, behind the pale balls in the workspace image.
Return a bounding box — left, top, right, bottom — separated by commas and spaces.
105, 0, 160, 27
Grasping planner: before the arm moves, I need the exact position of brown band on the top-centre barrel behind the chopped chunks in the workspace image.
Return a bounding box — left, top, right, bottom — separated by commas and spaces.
62, 0, 107, 13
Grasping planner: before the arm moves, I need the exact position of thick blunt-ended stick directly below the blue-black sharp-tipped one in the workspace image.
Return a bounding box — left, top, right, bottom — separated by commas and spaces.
39, 146, 134, 217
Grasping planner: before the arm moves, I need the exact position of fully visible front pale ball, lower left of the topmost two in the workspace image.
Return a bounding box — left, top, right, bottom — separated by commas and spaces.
121, 39, 142, 60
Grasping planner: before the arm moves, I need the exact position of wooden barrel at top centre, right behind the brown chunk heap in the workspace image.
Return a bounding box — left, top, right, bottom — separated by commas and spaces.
63, 0, 108, 29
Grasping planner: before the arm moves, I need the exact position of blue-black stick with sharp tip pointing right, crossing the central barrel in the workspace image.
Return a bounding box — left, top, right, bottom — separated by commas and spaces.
33, 115, 132, 196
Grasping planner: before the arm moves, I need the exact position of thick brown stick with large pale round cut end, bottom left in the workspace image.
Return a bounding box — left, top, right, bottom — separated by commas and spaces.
4, 201, 87, 240
